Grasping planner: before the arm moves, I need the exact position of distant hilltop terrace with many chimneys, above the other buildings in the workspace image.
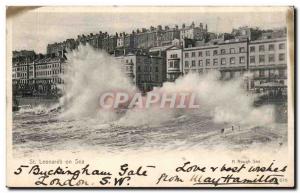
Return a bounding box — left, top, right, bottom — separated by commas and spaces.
47, 23, 209, 56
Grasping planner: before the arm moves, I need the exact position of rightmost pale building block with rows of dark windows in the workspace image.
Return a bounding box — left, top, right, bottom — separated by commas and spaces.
249, 37, 287, 90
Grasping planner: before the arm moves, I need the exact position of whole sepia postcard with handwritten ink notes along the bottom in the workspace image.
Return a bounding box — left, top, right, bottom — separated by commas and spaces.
6, 6, 295, 188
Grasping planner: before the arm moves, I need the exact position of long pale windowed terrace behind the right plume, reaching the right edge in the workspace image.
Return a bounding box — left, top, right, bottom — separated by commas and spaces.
177, 33, 287, 93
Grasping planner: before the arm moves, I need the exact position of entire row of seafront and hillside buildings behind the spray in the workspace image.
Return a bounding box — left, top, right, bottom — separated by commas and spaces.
12, 22, 287, 97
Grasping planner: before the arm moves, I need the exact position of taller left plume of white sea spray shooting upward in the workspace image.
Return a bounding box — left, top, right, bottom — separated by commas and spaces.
60, 46, 135, 121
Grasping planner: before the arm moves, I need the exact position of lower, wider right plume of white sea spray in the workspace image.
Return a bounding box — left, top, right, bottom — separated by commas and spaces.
155, 71, 274, 126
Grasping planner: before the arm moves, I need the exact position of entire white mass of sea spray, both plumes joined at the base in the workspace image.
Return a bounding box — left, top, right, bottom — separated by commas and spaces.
61, 46, 273, 126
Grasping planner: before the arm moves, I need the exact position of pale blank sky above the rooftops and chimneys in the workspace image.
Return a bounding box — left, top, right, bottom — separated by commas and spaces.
7, 6, 287, 53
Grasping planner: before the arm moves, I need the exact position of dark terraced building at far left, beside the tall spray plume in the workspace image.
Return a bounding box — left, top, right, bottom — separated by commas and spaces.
12, 51, 66, 96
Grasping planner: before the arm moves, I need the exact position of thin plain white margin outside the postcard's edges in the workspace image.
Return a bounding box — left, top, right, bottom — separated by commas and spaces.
0, 0, 300, 192
